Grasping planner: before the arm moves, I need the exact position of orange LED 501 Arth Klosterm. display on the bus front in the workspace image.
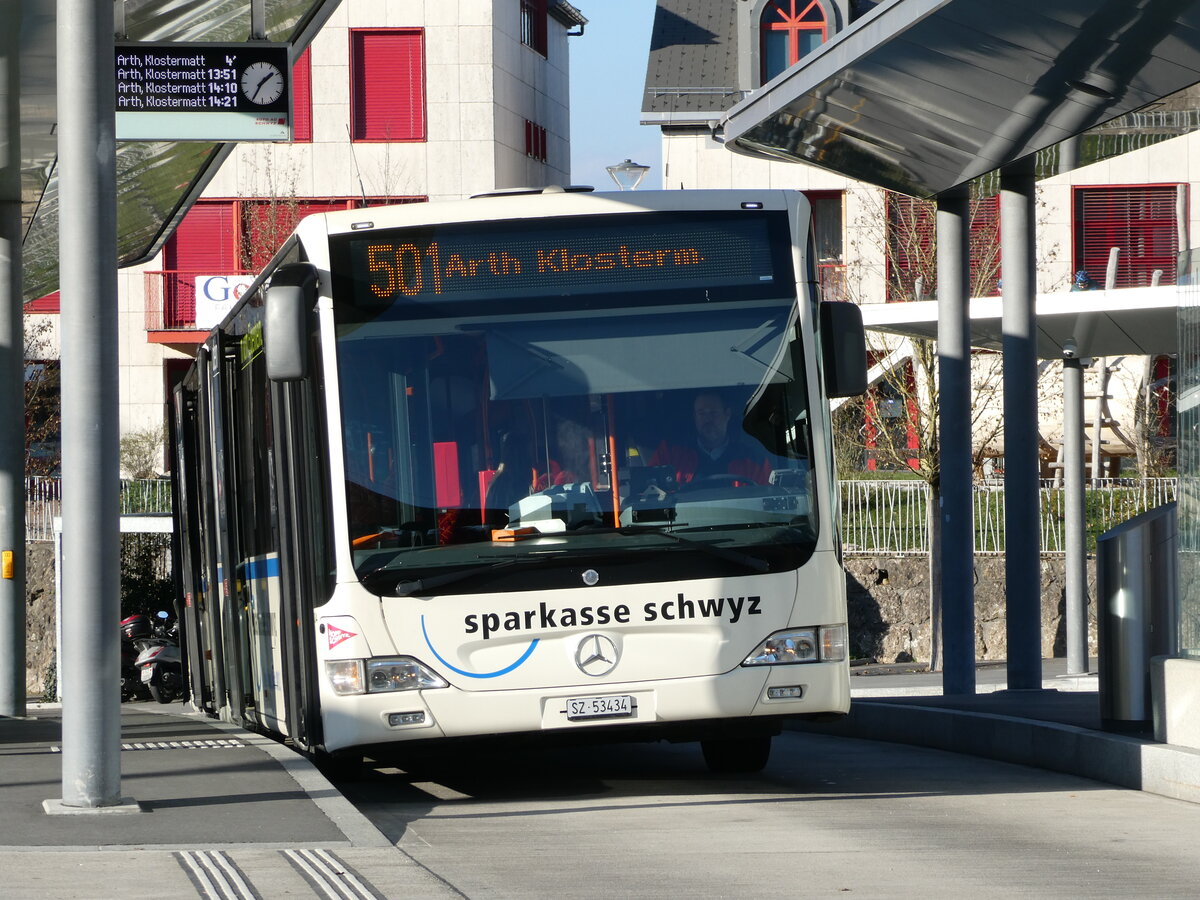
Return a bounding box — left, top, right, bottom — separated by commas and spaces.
335, 211, 792, 308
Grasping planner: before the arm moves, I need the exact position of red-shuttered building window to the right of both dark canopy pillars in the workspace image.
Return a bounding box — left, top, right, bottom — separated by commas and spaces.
1073, 185, 1181, 288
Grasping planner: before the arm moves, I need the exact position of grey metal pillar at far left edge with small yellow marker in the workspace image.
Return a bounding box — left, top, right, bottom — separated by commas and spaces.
0, 4, 25, 716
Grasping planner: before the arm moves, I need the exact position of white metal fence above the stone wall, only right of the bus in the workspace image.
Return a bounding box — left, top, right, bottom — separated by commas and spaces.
841, 478, 1178, 556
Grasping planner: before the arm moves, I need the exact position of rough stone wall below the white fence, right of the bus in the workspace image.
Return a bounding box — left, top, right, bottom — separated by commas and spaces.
846, 557, 1096, 662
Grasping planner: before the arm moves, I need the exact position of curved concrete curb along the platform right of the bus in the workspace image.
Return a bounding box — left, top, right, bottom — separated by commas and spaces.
787, 700, 1200, 803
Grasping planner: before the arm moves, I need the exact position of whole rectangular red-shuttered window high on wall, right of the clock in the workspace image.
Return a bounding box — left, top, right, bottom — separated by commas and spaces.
350, 29, 425, 143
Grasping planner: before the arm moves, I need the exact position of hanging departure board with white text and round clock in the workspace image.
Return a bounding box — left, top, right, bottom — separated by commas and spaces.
114, 42, 292, 140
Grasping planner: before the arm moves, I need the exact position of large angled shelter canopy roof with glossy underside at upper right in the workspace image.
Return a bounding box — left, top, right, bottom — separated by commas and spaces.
721, 0, 1200, 197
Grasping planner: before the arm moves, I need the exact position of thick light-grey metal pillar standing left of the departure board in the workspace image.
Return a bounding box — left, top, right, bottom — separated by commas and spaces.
43, 0, 136, 814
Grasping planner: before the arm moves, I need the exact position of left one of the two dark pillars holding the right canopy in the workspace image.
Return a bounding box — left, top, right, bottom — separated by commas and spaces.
937, 188, 976, 694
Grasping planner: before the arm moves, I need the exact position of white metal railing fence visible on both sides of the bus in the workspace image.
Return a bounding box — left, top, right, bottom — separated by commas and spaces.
25, 478, 1178, 556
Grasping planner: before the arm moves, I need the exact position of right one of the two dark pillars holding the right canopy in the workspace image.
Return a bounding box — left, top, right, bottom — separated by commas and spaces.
1000, 161, 1042, 690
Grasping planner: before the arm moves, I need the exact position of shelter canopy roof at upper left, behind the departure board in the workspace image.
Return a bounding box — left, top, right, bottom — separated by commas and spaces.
20, 0, 338, 300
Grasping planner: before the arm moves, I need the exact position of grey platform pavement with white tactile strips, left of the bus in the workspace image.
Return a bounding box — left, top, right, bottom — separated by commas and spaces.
0, 703, 457, 900
